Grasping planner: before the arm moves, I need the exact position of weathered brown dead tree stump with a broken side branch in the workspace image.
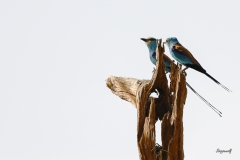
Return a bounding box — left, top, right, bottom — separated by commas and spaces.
106, 40, 187, 160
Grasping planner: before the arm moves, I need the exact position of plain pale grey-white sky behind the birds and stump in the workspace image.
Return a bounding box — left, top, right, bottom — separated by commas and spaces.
0, 0, 240, 160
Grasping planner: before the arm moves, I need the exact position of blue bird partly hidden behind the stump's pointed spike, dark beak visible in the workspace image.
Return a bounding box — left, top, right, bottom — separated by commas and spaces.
141, 37, 222, 117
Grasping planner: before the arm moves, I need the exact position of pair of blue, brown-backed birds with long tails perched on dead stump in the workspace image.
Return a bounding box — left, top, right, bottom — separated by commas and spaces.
141, 37, 231, 116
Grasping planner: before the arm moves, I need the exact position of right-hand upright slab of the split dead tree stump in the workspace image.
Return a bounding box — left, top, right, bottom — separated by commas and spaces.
161, 62, 187, 160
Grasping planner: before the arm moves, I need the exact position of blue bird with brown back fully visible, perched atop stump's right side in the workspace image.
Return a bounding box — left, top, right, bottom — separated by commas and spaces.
164, 37, 232, 92
